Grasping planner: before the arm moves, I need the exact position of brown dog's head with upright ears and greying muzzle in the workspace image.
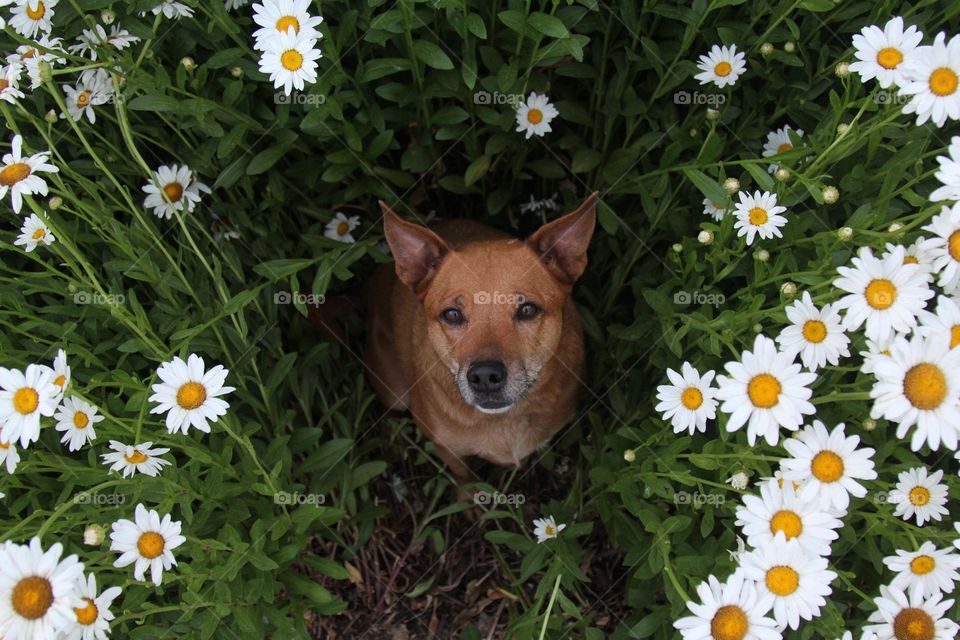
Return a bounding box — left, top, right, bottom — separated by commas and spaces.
380, 193, 597, 414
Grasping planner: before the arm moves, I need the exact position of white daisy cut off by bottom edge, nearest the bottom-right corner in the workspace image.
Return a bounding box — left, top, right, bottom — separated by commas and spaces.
866, 585, 960, 640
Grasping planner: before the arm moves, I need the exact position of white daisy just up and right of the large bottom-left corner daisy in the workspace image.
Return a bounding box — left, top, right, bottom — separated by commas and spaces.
110, 504, 187, 587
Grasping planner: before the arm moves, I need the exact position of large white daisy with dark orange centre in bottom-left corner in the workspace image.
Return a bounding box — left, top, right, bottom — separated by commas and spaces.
0, 538, 83, 640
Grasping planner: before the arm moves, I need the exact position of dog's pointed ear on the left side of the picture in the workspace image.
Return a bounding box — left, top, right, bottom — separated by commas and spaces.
380, 200, 448, 296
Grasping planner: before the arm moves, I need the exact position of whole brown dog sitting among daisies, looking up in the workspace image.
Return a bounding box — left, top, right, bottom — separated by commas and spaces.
365, 193, 597, 481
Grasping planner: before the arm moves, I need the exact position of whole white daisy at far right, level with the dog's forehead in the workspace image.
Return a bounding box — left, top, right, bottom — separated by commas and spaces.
833, 247, 934, 341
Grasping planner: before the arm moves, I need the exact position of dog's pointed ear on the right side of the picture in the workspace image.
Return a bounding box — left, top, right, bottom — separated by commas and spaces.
527, 191, 599, 285
